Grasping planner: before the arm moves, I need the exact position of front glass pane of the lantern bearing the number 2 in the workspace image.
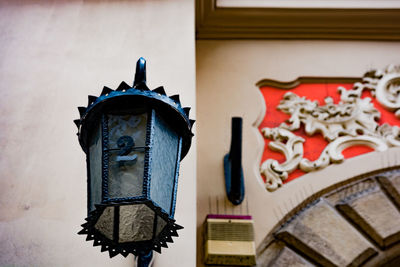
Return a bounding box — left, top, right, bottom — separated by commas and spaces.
108, 113, 147, 198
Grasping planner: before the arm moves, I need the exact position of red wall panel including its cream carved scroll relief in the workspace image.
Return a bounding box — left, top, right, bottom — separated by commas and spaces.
259, 66, 400, 191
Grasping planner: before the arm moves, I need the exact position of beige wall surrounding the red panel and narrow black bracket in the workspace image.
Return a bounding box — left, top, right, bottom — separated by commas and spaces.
196, 40, 400, 266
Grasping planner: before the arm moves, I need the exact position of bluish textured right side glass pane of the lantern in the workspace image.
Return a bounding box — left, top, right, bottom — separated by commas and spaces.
150, 114, 179, 214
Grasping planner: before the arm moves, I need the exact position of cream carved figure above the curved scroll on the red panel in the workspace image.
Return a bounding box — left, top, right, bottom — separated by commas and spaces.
278, 90, 380, 141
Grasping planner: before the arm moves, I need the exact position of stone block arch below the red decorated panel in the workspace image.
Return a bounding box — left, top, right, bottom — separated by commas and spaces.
257, 168, 400, 266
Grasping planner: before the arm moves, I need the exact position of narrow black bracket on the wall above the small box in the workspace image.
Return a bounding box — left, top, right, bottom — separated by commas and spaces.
224, 117, 244, 205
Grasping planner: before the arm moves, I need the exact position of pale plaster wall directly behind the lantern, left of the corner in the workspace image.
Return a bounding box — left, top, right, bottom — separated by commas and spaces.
0, 0, 196, 267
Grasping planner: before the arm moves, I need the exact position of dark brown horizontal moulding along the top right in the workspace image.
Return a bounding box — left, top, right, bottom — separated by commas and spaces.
196, 0, 400, 41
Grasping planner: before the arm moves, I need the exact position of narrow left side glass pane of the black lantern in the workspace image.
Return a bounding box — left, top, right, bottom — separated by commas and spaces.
89, 123, 102, 212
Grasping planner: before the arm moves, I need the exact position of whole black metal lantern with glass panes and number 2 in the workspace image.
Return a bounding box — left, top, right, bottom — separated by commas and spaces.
74, 58, 194, 257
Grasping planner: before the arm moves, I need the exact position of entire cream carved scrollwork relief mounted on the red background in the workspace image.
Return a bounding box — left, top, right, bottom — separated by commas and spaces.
260, 66, 400, 191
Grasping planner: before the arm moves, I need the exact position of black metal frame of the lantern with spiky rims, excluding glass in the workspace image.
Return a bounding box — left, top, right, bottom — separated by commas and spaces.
74, 58, 195, 257
